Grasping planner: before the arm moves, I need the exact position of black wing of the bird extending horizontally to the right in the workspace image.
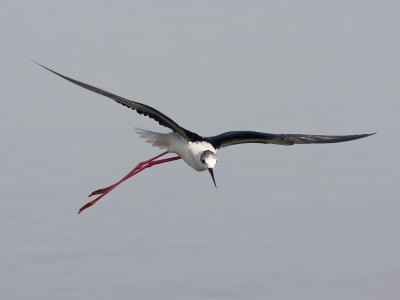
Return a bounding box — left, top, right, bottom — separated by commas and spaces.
204, 131, 375, 149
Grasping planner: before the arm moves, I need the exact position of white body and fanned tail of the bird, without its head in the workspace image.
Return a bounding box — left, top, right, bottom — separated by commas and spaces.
137, 129, 216, 172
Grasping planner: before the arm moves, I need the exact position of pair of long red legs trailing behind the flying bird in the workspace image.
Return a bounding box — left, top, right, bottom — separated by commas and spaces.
78, 151, 181, 215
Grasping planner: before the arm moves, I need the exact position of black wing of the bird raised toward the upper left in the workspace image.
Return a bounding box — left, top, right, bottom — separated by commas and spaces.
34, 62, 204, 142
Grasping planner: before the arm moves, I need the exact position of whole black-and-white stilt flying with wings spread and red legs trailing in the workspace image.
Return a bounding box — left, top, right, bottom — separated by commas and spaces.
35, 62, 375, 214
